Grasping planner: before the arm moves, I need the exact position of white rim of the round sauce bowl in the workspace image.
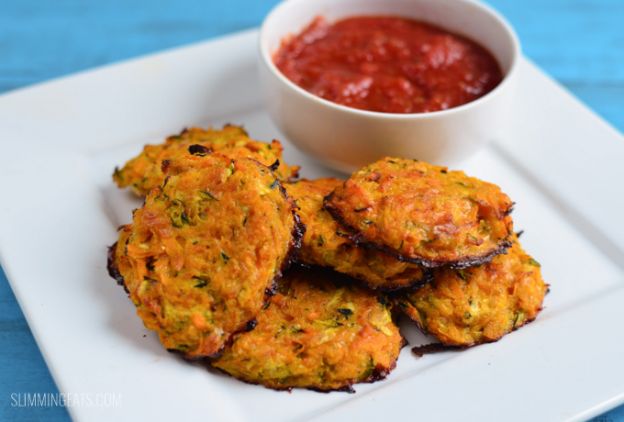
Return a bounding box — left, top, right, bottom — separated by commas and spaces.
258, 0, 522, 120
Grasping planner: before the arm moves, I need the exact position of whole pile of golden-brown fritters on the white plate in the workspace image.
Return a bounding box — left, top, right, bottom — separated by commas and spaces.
109, 126, 547, 391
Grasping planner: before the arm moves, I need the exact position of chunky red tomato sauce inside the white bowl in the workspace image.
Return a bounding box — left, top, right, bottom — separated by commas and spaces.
274, 16, 502, 113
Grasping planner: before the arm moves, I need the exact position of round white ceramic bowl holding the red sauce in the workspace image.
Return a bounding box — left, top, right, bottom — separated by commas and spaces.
260, 0, 520, 172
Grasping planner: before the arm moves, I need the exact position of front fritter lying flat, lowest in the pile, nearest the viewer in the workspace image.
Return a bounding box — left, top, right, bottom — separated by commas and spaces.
213, 269, 404, 391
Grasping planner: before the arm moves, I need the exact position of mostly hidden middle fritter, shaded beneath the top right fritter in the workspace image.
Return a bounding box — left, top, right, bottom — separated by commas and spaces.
284, 178, 426, 290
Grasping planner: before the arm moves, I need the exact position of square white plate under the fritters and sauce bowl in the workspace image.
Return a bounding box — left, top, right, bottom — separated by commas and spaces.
0, 32, 624, 421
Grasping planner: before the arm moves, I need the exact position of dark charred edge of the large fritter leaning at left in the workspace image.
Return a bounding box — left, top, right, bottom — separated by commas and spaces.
106, 158, 305, 361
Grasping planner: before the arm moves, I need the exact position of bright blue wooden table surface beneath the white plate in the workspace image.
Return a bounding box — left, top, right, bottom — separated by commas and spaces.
0, 0, 624, 422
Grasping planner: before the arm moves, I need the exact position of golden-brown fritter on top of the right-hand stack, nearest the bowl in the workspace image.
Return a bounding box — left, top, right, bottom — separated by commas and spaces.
325, 157, 513, 268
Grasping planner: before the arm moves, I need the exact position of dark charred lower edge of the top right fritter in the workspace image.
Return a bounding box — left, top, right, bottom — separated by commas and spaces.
323, 192, 511, 269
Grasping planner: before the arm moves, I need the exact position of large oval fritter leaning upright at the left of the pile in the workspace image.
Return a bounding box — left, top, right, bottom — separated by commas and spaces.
109, 154, 300, 358
